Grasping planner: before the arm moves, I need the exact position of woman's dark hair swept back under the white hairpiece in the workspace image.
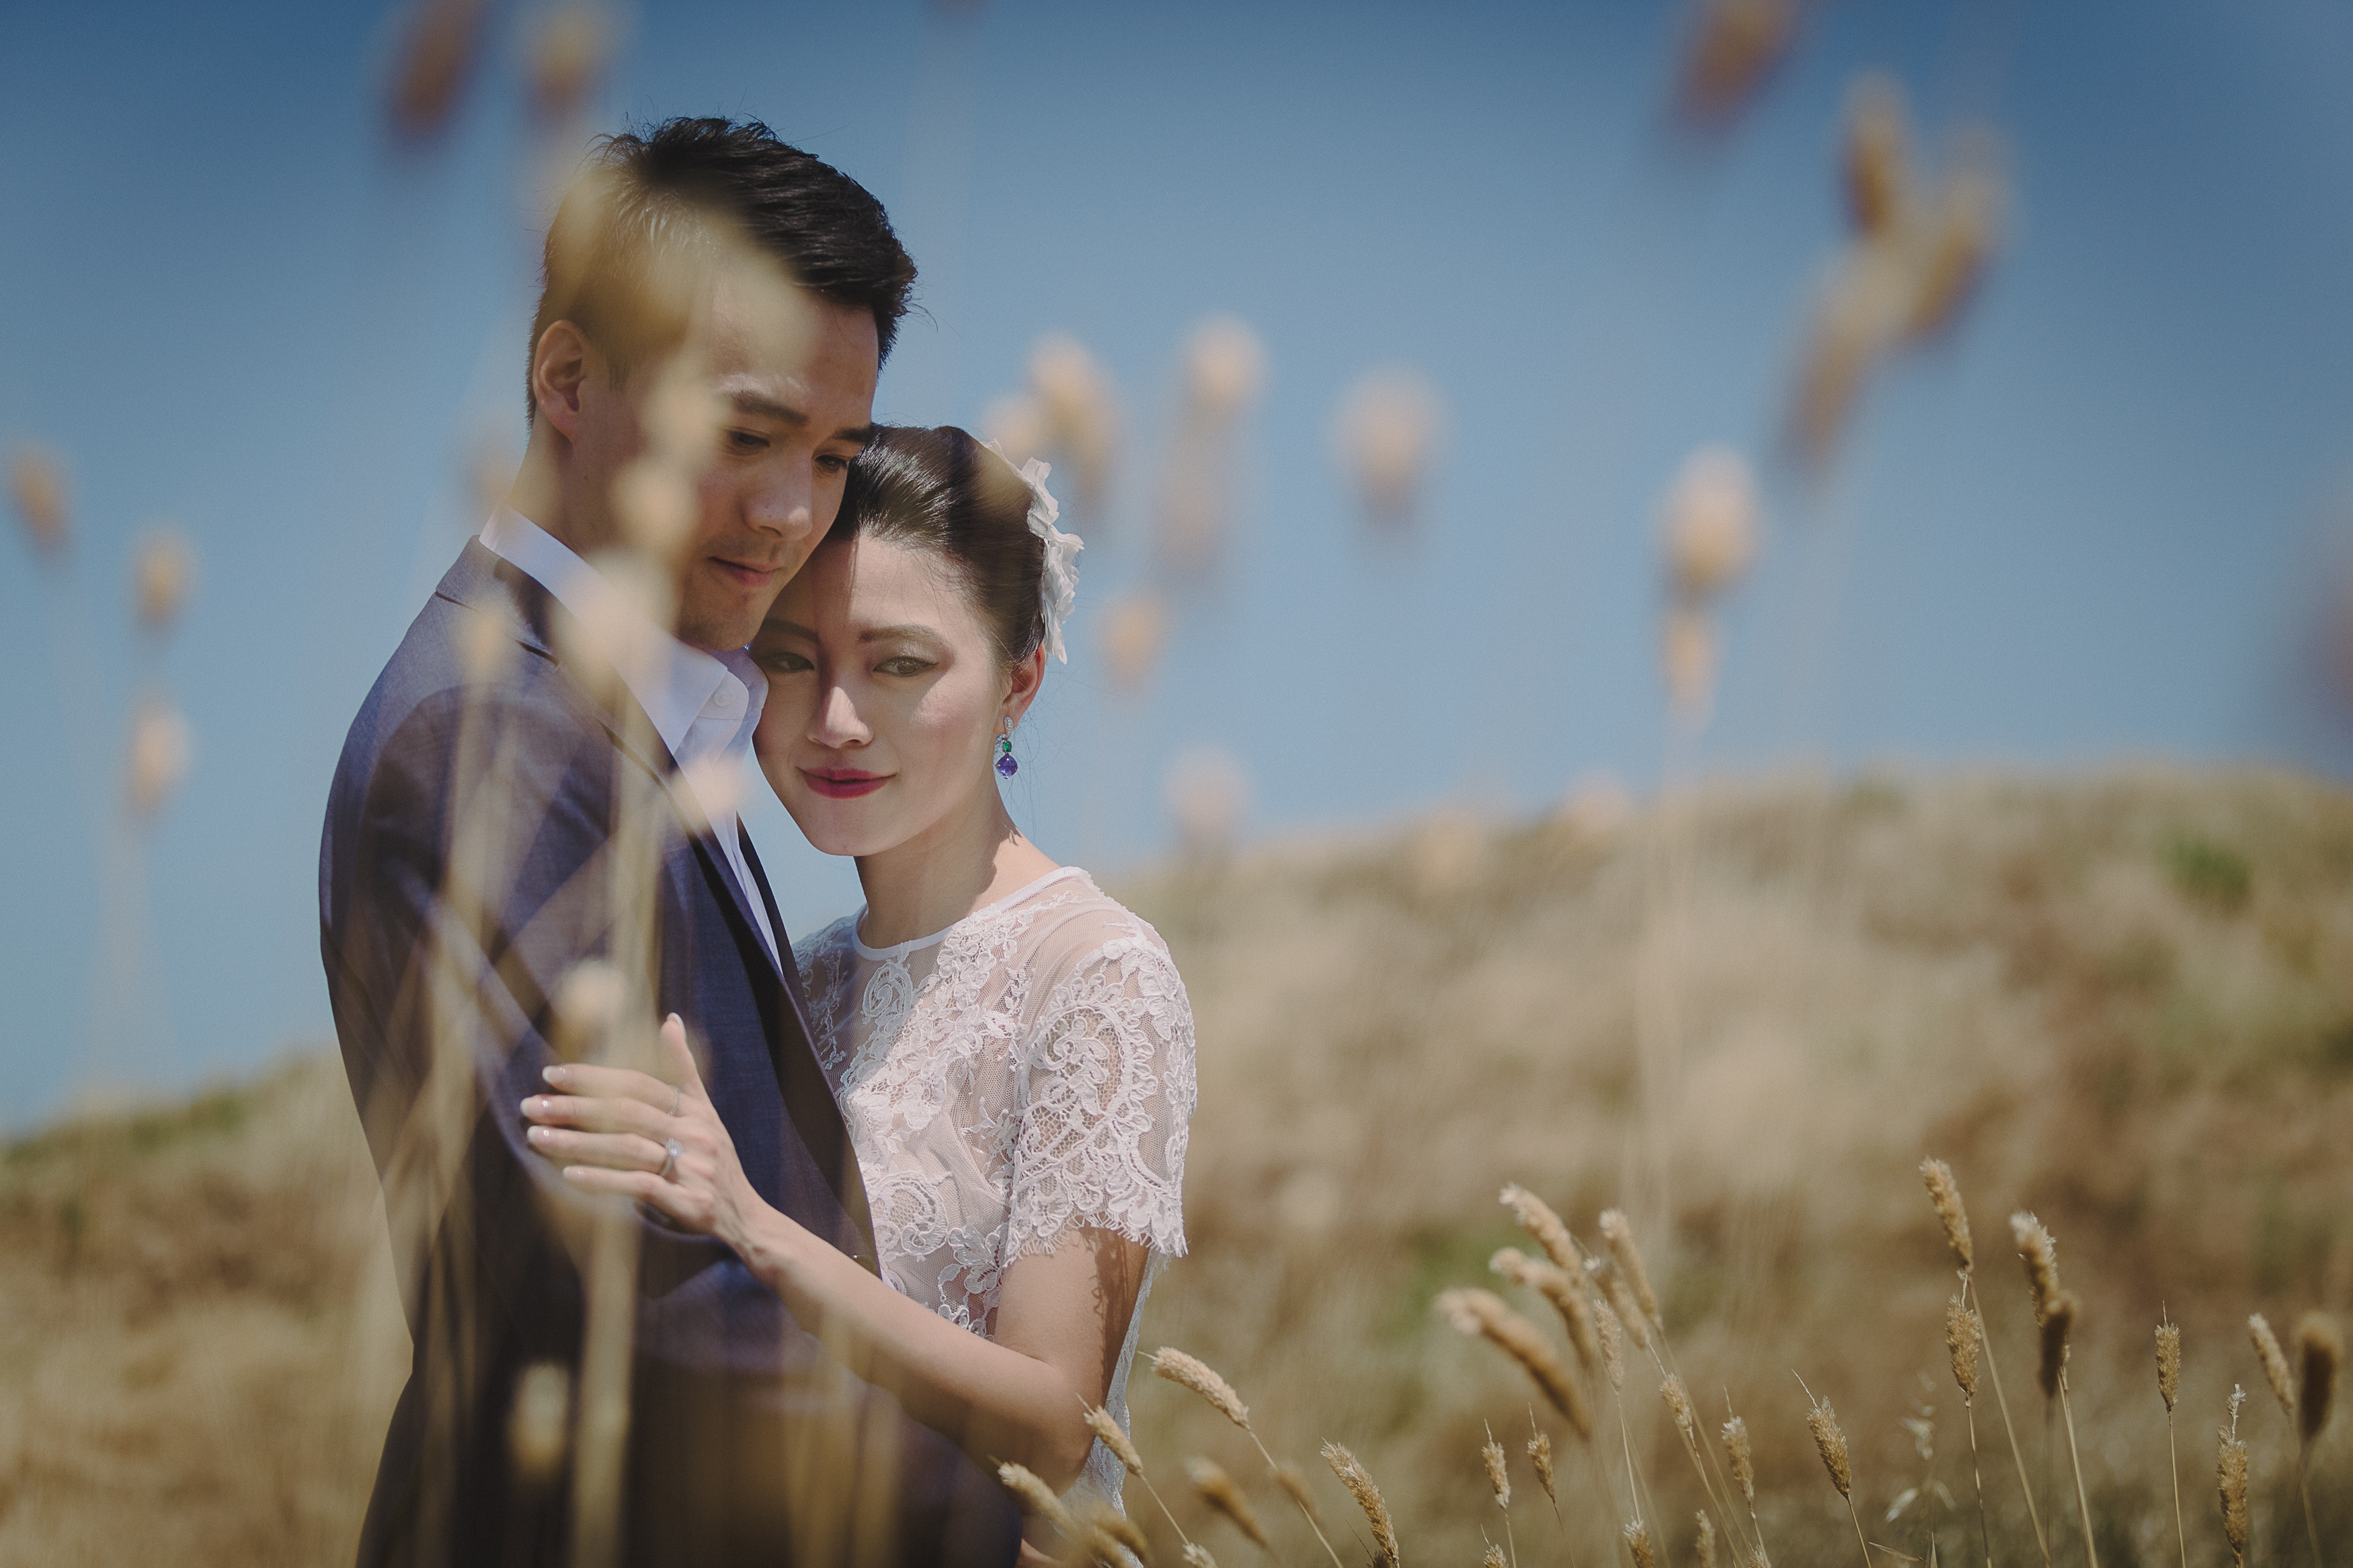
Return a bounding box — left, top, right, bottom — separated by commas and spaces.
826, 425, 1045, 663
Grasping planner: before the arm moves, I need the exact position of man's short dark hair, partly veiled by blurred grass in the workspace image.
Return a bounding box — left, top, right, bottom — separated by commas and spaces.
525, 120, 916, 414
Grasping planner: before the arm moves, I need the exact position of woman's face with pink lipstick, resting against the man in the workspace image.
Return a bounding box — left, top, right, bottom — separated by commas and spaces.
751, 536, 1040, 856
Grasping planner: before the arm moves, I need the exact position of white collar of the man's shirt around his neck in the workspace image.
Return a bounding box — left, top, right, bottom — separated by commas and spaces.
483, 505, 767, 764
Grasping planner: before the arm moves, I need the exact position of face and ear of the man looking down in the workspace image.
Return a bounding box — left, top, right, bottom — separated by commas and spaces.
574, 273, 880, 651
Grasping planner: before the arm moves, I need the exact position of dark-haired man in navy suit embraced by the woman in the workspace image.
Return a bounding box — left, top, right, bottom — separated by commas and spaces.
320, 120, 1019, 1566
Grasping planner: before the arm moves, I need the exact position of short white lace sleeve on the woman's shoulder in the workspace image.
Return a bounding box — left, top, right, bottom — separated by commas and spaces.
1005, 936, 1195, 1262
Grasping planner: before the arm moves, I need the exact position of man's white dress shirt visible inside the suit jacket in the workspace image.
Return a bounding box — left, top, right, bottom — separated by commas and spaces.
483, 505, 781, 968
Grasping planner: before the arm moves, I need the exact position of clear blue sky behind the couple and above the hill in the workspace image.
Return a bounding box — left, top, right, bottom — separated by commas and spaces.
0, 0, 2353, 1124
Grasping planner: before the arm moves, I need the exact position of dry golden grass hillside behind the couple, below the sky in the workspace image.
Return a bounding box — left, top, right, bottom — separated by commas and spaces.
0, 771, 2353, 1568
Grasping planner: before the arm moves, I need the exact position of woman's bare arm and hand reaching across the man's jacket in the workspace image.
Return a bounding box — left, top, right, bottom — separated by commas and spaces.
522, 1016, 1146, 1491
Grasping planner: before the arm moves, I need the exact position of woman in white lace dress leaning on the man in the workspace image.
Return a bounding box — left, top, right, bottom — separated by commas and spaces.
527, 428, 1193, 1542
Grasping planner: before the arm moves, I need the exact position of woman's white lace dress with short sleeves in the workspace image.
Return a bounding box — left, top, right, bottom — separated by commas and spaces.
793, 865, 1195, 1507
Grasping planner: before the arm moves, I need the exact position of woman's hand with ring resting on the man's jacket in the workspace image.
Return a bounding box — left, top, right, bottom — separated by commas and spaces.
522, 1014, 765, 1251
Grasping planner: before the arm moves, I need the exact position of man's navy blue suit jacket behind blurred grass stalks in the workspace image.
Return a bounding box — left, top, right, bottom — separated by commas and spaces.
320, 540, 1019, 1568
